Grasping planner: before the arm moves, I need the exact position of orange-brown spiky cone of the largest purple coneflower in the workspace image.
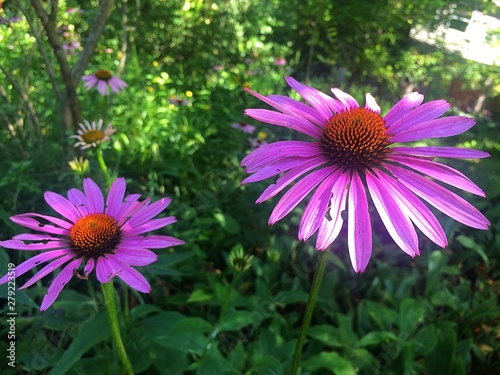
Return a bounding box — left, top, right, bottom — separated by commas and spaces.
320, 108, 391, 172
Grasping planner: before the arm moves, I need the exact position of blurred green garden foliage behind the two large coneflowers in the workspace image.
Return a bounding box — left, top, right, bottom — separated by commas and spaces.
0, 0, 500, 375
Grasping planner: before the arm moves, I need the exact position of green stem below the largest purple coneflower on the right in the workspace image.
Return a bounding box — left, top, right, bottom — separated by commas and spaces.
291, 250, 328, 375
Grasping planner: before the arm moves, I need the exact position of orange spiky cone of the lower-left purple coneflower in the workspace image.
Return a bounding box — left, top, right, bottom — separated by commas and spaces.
69, 213, 122, 259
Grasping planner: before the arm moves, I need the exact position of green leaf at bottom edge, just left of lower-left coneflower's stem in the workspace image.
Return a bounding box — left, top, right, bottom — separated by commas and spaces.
49, 311, 111, 375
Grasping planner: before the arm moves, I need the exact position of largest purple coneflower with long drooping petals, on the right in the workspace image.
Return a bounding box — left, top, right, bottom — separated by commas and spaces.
241, 77, 489, 272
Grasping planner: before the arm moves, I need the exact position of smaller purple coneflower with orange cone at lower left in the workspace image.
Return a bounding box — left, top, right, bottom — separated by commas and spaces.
0, 178, 184, 311
